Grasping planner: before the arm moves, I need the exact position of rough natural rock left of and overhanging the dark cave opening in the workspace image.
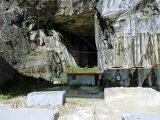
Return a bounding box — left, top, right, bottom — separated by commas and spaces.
0, 0, 96, 83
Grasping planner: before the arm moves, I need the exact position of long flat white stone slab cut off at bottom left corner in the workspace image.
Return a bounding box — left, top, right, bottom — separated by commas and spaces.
0, 107, 58, 120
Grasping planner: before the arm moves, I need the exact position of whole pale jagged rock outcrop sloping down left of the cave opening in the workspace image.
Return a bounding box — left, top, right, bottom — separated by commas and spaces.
21, 30, 76, 82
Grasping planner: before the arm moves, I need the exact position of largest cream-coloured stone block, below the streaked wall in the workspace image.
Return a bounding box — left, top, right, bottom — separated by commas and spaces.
104, 87, 160, 113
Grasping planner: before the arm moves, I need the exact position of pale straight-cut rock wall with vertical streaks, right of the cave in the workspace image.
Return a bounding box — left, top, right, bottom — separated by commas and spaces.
95, 0, 160, 86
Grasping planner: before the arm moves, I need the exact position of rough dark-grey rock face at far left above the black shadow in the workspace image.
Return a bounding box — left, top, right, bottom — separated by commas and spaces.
0, 3, 29, 69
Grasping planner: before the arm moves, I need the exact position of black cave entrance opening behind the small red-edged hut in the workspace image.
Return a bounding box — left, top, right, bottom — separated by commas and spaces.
64, 35, 97, 67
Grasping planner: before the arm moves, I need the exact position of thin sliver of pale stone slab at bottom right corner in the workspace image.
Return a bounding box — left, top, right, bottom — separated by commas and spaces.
122, 114, 160, 120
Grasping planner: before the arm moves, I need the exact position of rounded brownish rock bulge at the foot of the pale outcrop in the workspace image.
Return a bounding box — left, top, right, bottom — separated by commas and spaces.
21, 48, 56, 82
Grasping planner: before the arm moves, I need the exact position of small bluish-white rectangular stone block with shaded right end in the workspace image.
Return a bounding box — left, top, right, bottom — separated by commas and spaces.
26, 91, 66, 107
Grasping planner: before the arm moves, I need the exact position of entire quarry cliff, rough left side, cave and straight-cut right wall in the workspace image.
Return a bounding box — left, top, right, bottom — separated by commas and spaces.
0, 0, 160, 86
